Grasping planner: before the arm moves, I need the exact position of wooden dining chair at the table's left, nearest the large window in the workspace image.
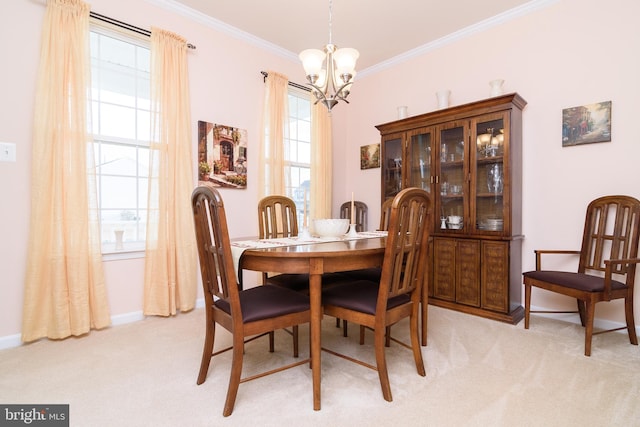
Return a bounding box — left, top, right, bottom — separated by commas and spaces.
191, 185, 311, 417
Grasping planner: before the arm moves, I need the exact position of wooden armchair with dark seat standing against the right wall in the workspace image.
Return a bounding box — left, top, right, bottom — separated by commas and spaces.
523, 196, 640, 356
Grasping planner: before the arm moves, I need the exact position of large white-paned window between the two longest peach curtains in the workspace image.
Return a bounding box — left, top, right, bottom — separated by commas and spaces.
91, 27, 151, 253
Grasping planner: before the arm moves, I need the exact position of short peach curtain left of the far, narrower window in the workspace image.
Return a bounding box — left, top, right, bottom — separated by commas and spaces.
258, 71, 289, 198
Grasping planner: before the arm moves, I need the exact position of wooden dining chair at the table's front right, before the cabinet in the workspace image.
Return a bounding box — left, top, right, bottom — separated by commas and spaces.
322, 188, 432, 401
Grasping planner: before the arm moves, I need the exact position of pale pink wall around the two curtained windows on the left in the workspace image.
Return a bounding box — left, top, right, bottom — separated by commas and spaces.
0, 0, 320, 349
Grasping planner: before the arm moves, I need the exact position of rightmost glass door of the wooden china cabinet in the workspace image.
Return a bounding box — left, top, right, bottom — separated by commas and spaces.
472, 114, 509, 233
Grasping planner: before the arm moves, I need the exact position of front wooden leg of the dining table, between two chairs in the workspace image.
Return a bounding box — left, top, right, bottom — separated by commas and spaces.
309, 259, 322, 411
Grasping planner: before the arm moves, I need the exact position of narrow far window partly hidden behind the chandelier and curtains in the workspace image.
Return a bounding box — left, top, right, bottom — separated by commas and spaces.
284, 86, 311, 227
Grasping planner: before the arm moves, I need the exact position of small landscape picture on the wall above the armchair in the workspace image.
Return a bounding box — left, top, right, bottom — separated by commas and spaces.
562, 101, 611, 147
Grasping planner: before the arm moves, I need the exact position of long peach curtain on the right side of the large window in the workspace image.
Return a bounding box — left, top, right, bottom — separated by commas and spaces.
144, 28, 198, 316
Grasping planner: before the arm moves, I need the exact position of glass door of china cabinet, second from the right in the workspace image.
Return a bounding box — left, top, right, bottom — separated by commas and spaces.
435, 122, 468, 231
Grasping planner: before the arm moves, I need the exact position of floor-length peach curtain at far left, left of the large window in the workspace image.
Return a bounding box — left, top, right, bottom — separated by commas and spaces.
22, 0, 110, 342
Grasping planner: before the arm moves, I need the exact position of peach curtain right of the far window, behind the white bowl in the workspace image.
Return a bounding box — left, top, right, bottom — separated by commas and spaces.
310, 94, 333, 218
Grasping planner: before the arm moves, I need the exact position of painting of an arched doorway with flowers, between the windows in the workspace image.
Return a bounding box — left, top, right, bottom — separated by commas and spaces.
198, 121, 247, 189
